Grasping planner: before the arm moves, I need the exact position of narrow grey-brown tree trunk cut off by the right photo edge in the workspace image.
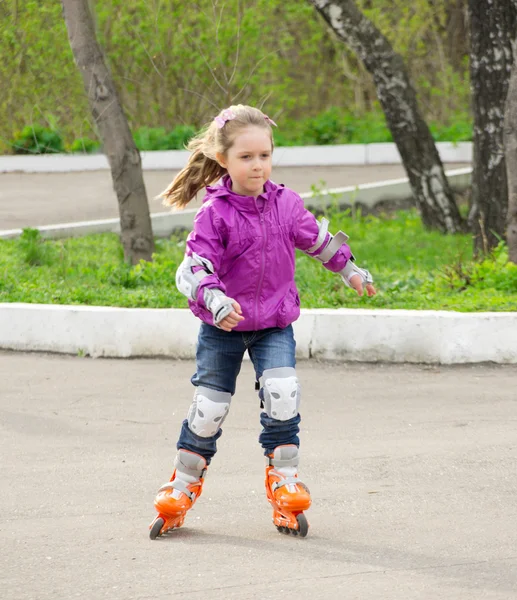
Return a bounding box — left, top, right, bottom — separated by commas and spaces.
503, 5, 517, 264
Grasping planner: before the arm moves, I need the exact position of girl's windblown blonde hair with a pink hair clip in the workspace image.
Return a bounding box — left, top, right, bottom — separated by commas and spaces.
158, 104, 273, 208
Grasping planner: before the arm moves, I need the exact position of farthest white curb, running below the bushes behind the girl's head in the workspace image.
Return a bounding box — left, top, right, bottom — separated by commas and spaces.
0, 142, 472, 173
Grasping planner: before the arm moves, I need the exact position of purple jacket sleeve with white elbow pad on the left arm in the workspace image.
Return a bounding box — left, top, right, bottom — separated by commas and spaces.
176, 202, 226, 312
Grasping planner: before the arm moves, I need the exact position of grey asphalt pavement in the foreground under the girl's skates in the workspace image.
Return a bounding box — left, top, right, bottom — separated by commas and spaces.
0, 352, 517, 600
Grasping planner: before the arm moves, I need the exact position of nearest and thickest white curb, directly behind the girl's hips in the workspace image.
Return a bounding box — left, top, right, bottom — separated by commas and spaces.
0, 304, 517, 364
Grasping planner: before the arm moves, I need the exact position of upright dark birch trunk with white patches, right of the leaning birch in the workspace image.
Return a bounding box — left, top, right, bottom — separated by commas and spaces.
469, 0, 516, 253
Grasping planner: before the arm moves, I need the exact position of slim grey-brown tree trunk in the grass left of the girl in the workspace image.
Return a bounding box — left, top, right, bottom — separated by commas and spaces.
62, 0, 154, 264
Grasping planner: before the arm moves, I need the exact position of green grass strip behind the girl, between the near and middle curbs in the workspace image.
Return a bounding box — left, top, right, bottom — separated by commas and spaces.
0, 211, 517, 311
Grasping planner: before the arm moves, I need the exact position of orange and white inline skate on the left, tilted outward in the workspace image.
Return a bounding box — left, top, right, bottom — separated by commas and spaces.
149, 450, 206, 540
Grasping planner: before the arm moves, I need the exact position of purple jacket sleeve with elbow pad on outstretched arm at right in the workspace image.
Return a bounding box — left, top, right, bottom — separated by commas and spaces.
295, 197, 353, 273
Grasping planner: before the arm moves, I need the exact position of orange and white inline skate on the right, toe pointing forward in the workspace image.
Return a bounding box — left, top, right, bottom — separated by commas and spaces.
265, 445, 311, 537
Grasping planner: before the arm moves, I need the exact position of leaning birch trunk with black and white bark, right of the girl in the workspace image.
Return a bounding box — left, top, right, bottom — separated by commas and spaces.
309, 0, 464, 233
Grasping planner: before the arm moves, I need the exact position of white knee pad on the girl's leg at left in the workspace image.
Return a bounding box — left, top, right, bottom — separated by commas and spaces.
187, 386, 232, 437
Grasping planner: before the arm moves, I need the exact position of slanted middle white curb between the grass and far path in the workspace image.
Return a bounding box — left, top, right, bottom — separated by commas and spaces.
0, 167, 472, 240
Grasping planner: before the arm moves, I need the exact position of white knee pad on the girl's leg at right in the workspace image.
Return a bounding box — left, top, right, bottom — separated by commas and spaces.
260, 367, 300, 421
